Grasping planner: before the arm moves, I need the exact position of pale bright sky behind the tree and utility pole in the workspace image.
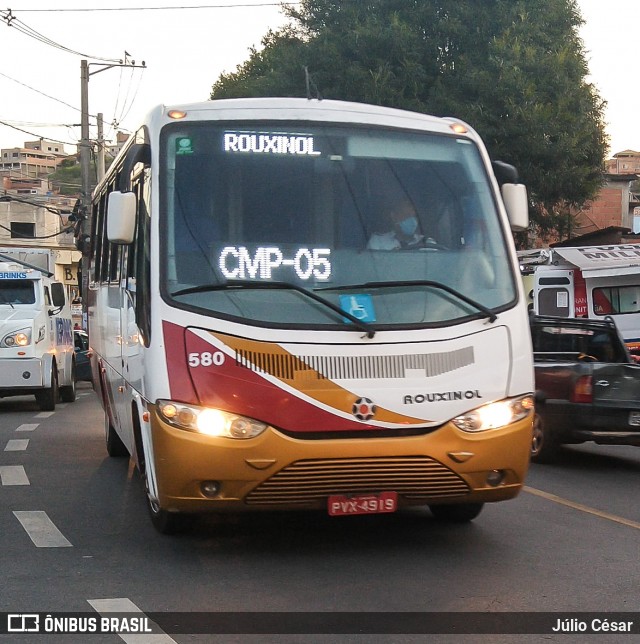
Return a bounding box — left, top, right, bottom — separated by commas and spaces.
0, 0, 640, 156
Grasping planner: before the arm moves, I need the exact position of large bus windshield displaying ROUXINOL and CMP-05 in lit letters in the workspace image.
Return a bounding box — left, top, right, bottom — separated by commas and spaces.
160, 122, 516, 328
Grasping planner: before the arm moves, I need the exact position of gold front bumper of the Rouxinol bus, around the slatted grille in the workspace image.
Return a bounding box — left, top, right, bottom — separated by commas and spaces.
150, 408, 532, 513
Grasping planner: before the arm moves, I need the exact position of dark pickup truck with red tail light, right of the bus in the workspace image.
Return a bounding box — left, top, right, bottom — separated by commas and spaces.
530, 315, 640, 463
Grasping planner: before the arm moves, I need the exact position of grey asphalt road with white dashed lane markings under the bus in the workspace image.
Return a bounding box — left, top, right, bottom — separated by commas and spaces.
0, 383, 640, 644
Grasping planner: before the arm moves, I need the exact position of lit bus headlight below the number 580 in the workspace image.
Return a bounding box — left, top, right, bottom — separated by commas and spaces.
158, 400, 267, 438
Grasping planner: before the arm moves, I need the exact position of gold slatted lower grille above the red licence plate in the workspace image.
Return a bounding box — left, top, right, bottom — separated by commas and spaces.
245, 456, 469, 505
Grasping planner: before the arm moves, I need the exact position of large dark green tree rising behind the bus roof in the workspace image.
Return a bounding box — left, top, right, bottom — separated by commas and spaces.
211, 0, 608, 242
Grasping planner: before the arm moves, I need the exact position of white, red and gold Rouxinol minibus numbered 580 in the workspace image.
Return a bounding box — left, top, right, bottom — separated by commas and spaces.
84, 98, 533, 532
